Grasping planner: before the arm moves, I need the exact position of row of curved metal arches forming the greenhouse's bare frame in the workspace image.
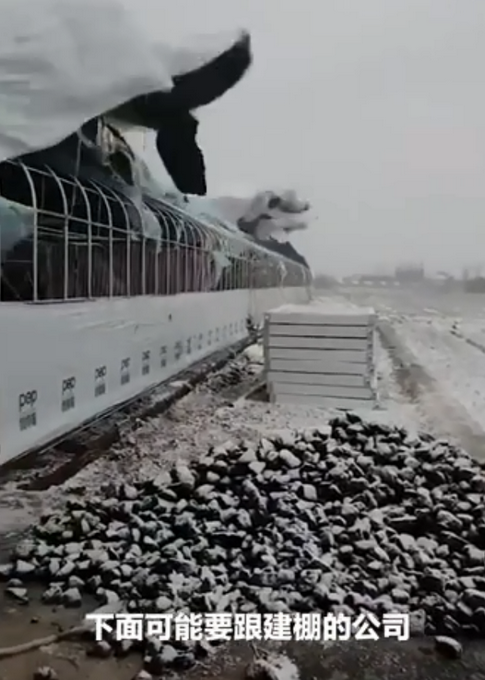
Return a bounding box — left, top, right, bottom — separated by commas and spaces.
0, 161, 312, 301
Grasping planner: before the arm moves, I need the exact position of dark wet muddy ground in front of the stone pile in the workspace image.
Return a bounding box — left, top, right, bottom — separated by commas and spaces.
0, 584, 485, 680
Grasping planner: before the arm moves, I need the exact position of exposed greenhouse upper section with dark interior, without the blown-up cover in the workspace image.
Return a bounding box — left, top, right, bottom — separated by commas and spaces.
0, 121, 310, 300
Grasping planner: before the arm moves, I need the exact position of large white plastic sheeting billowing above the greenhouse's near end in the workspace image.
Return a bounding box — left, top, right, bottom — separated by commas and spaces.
0, 0, 244, 162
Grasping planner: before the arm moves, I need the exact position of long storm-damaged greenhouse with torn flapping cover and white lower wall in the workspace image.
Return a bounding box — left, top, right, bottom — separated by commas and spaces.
0, 0, 311, 463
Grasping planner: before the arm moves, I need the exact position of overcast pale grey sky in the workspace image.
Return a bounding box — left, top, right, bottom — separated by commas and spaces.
133, 0, 485, 274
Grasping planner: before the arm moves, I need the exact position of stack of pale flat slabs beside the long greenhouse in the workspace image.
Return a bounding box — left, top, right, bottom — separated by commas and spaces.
264, 300, 377, 409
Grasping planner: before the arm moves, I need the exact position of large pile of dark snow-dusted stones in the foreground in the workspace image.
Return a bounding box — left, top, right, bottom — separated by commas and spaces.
0, 413, 485, 668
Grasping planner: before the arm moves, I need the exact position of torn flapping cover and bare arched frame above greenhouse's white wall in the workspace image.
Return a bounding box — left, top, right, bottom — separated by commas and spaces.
0, 0, 307, 299
